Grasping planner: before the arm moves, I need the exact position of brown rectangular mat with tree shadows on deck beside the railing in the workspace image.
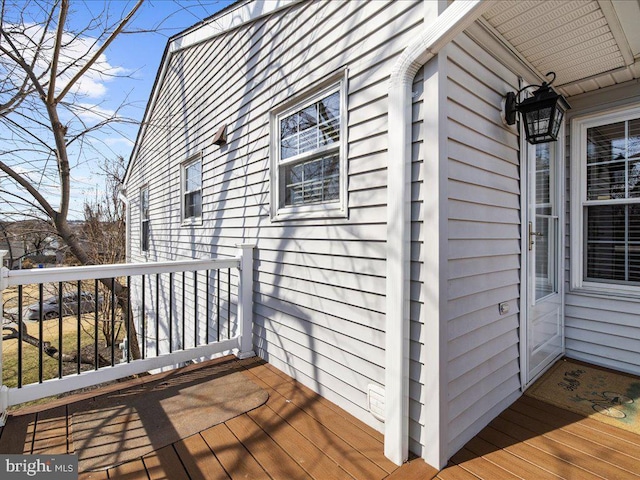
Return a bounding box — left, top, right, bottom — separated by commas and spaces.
69, 365, 268, 472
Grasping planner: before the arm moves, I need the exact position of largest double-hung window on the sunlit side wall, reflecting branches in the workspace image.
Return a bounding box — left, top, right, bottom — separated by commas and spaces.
271, 76, 346, 220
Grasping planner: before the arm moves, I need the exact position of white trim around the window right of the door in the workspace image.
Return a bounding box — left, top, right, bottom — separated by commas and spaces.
571, 104, 640, 296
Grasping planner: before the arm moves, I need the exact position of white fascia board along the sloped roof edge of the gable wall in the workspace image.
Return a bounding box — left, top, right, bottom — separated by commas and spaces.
123, 0, 300, 185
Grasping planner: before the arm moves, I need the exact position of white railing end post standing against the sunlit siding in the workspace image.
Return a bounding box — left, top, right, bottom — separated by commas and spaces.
238, 243, 255, 359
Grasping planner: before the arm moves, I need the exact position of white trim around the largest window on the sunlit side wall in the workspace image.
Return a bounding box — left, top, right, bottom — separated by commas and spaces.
269, 70, 348, 222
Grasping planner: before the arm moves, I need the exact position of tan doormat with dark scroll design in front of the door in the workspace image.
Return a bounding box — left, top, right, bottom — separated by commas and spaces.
526, 360, 640, 434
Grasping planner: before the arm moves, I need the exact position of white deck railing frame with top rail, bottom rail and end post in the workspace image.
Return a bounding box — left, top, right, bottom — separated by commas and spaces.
0, 243, 255, 426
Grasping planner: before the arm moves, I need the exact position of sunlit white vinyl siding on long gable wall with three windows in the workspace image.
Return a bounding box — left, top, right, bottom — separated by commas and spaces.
128, 1, 424, 430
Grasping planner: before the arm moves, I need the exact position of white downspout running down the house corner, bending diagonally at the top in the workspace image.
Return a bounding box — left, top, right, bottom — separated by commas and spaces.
384, 0, 495, 468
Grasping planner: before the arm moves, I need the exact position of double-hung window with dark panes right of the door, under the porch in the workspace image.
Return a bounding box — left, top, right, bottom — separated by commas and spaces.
573, 107, 640, 290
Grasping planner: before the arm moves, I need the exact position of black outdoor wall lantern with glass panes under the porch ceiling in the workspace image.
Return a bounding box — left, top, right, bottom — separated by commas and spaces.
504, 72, 571, 145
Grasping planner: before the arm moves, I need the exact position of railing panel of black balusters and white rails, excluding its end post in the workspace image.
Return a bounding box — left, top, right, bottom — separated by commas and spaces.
0, 254, 250, 401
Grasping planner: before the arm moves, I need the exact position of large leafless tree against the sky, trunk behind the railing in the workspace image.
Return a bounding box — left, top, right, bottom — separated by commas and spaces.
0, 0, 143, 358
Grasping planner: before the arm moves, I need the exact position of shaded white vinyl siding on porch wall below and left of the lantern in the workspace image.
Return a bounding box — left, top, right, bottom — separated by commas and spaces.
442, 35, 521, 455
